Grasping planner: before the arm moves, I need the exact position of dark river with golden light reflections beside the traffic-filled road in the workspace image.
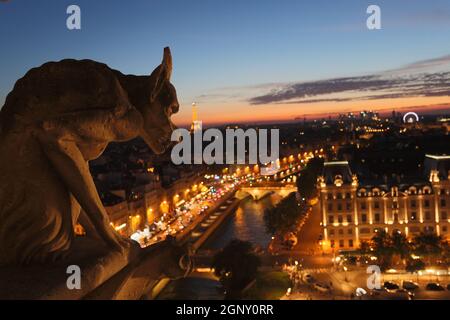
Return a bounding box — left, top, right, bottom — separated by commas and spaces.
158, 193, 282, 300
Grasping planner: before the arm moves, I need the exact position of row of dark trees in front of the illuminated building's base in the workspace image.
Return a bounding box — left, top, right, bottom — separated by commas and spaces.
360, 230, 450, 272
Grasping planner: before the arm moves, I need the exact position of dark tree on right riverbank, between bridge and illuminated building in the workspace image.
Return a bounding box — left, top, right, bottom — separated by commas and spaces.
264, 192, 305, 234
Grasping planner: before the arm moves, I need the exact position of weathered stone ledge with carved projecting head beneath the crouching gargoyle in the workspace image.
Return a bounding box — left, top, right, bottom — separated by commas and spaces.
0, 238, 192, 300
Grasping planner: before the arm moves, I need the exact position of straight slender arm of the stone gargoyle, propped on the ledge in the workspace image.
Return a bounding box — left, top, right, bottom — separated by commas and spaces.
37, 130, 121, 250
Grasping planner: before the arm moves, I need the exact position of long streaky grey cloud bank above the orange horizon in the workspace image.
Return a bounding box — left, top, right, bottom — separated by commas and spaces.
248, 55, 450, 105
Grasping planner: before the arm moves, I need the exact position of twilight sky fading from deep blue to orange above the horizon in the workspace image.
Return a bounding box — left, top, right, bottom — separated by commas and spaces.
0, 0, 450, 124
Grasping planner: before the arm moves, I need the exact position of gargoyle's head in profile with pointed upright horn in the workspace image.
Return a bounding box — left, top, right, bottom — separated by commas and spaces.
140, 47, 179, 154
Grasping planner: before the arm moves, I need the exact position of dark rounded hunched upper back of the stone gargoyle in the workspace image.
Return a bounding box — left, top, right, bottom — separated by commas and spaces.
1, 59, 123, 126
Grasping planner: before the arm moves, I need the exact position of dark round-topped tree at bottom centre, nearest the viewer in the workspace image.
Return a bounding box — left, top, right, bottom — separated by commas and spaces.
212, 239, 261, 299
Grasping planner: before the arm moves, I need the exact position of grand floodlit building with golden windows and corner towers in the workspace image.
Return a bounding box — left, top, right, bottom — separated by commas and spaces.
318, 155, 450, 252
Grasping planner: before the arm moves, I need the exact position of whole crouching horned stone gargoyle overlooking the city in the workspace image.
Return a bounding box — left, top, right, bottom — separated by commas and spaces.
0, 48, 179, 265
